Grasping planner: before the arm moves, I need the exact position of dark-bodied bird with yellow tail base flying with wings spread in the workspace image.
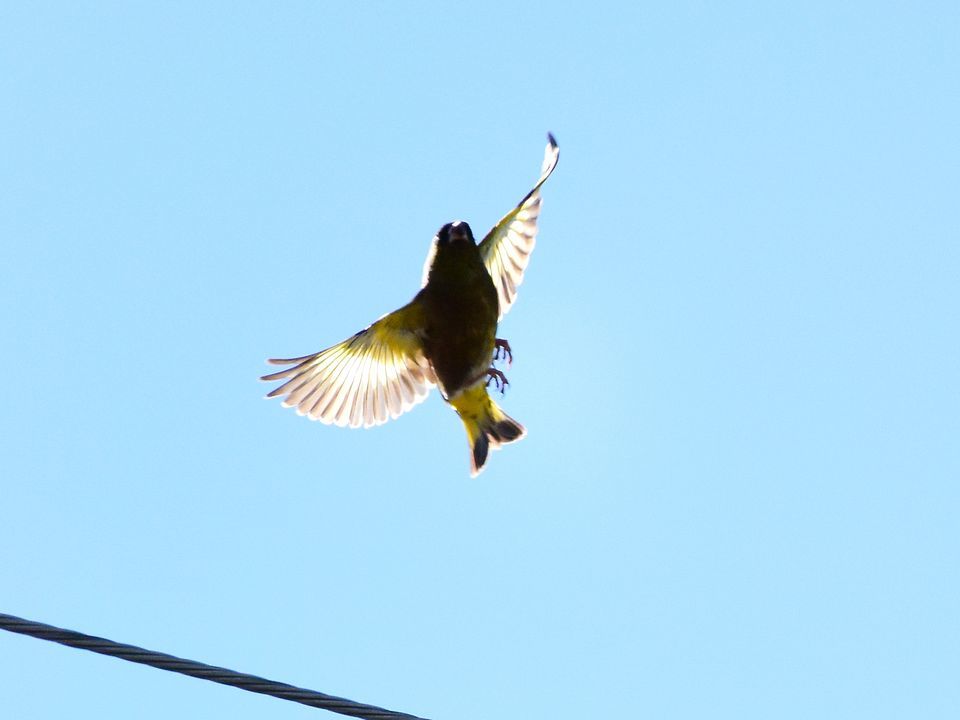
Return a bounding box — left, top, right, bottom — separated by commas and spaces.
260, 133, 560, 477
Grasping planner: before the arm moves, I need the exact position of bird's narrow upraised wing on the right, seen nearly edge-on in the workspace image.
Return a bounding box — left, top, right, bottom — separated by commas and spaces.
478, 134, 560, 317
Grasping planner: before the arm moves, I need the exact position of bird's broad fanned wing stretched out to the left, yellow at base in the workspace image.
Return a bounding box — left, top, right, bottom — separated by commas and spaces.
260, 303, 436, 427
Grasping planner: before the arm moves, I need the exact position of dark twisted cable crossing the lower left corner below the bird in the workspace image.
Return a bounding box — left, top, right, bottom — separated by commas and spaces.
0, 613, 424, 720
